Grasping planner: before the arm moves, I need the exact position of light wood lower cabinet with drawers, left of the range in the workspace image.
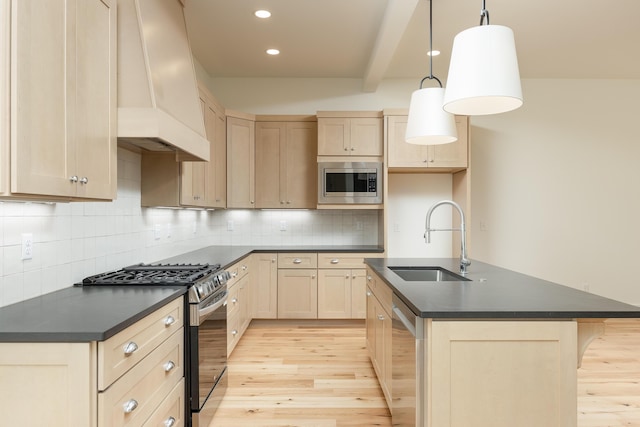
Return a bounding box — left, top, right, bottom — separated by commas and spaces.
0, 298, 185, 427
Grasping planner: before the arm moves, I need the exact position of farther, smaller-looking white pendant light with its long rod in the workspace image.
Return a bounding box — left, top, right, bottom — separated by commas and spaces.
405, 0, 458, 145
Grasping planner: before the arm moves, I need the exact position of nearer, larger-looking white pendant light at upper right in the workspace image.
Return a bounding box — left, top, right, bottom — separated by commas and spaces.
444, 0, 522, 116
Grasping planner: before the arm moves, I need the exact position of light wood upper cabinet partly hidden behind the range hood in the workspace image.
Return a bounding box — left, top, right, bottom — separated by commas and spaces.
141, 86, 227, 208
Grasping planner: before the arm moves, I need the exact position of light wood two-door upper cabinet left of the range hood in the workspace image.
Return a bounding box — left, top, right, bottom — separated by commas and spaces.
0, 0, 117, 200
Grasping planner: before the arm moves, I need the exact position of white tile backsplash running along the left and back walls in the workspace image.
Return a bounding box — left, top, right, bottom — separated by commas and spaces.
0, 149, 379, 307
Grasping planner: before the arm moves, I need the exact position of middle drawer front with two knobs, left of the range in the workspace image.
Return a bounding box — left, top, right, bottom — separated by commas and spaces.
98, 331, 184, 427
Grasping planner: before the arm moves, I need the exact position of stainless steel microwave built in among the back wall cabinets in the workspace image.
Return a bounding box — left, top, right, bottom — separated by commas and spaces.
318, 162, 382, 204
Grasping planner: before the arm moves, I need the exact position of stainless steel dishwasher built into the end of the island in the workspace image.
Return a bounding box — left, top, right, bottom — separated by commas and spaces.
391, 294, 425, 427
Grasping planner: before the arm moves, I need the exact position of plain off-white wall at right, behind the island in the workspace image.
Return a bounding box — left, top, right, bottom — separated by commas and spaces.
471, 80, 640, 305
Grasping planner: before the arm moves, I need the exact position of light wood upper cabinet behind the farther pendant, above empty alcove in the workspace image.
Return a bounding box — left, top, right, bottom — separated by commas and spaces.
386, 115, 469, 172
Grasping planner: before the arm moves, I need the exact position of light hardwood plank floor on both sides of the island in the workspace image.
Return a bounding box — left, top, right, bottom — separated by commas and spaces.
210, 319, 640, 427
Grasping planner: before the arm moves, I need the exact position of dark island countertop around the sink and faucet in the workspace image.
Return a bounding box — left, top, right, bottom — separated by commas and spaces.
365, 258, 640, 319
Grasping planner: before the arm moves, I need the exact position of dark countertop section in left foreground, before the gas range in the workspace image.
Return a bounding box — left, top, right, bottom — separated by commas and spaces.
0, 286, 187, 342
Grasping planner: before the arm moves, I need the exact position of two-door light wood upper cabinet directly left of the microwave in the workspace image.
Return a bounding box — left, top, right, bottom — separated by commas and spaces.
256, 117, 318, 209
